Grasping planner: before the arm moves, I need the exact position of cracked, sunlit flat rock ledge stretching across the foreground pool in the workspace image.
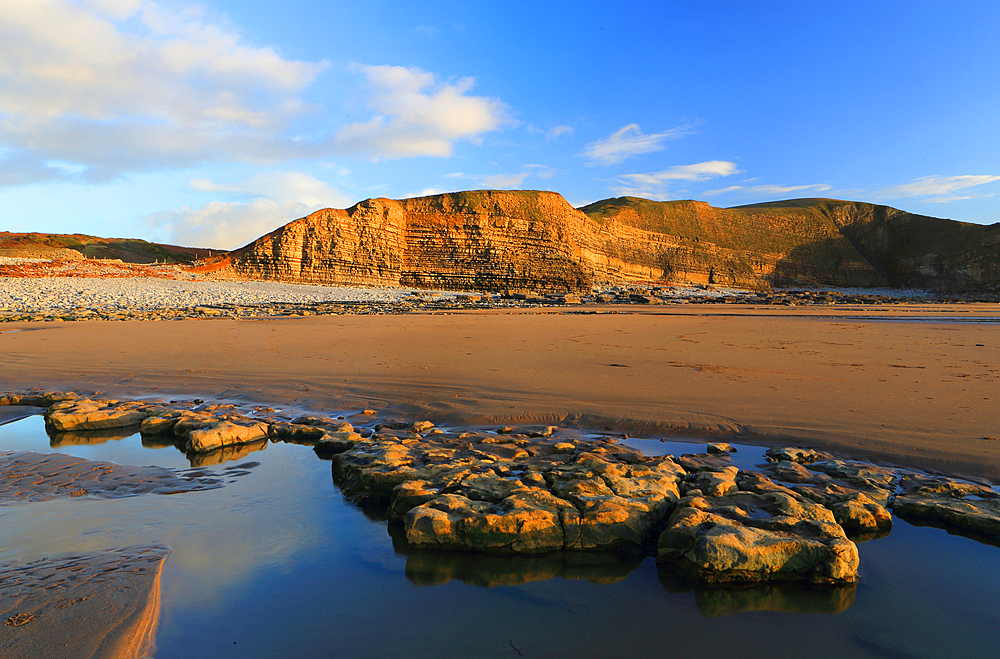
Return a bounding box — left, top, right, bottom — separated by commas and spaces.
0, 392, 1000, 586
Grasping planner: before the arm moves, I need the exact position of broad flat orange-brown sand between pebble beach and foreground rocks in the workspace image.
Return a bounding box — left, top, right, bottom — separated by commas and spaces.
0, 304, 1000, 479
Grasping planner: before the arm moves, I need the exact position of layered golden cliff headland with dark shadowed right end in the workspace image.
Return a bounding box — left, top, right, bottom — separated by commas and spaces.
220, 191, 1000, 292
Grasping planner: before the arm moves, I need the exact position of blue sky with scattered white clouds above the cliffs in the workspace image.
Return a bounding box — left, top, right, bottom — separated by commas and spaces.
0, 0, 1000, 249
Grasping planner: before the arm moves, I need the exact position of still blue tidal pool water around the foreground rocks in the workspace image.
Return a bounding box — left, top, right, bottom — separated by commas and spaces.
0, 417, 1000, 659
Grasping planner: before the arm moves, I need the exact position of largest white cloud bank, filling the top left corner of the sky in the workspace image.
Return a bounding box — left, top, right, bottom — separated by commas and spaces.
0, 0, 327, 181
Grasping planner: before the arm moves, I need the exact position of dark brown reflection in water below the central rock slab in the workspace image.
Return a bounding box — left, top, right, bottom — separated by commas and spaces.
406, 551, 643, 588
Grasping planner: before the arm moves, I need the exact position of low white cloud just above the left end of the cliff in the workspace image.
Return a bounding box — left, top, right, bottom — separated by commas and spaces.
145, 171, 351, 250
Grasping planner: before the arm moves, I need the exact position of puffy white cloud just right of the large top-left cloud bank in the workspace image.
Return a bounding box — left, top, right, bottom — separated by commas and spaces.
334, 64, 506, 158
